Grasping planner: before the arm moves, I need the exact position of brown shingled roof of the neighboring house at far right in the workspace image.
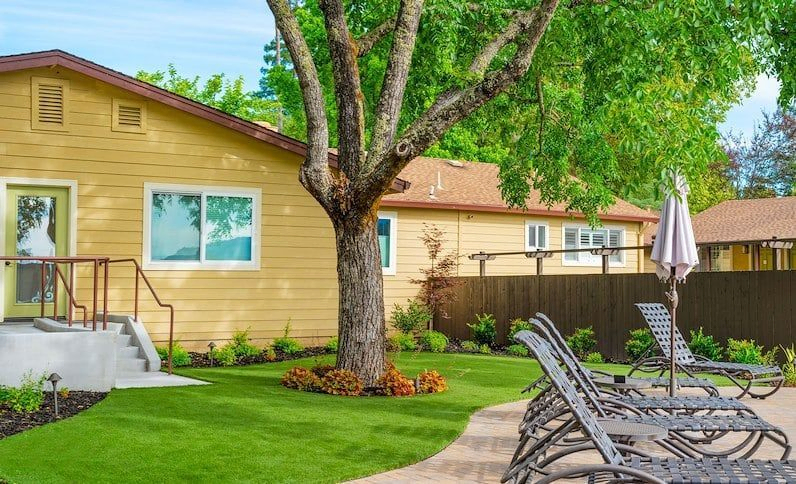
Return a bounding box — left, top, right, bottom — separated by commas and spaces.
692, 197, 796, 244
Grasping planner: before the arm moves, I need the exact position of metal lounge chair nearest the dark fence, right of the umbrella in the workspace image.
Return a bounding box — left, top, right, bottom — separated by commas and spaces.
630, 303, 784, 399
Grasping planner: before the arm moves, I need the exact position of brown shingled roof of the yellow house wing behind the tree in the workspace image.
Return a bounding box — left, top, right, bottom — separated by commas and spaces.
382, 157, 658, 222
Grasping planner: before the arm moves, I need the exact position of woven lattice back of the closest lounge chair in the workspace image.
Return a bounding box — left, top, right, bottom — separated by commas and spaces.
514, 330, 625, 465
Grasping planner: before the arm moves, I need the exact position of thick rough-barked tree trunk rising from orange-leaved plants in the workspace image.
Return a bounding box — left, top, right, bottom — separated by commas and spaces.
333, 212, 386, 386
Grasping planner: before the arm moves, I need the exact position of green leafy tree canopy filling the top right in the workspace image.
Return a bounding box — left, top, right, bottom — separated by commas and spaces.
261, 0, 796, 221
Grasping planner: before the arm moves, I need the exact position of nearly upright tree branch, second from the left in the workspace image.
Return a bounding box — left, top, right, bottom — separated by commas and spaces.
319, 0, 365, 179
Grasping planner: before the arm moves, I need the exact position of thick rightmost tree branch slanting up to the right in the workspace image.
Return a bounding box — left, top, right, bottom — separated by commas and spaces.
366, 0, 560, 199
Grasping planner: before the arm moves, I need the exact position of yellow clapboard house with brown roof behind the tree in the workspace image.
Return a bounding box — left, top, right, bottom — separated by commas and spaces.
0, 51, 655, 349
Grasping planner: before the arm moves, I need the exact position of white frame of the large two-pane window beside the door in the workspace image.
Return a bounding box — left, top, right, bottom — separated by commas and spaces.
142, 182, 262, 271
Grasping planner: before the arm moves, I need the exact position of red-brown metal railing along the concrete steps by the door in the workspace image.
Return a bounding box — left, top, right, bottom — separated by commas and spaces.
0, 256, 174, 375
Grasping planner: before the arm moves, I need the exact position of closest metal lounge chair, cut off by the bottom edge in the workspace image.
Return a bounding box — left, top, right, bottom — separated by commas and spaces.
501, 331, 796, 484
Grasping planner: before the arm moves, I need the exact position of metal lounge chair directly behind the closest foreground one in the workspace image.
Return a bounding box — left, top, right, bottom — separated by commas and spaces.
520, 319, 791, 459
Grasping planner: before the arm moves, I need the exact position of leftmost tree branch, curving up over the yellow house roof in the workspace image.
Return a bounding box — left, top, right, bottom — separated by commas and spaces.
268, 0, 334, 208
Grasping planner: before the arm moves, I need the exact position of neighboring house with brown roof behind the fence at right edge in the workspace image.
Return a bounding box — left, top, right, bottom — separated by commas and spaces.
644, 197, 796, 272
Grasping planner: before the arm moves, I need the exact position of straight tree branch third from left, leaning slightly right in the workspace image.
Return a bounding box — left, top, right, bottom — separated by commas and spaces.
367, 0, 423, 172
